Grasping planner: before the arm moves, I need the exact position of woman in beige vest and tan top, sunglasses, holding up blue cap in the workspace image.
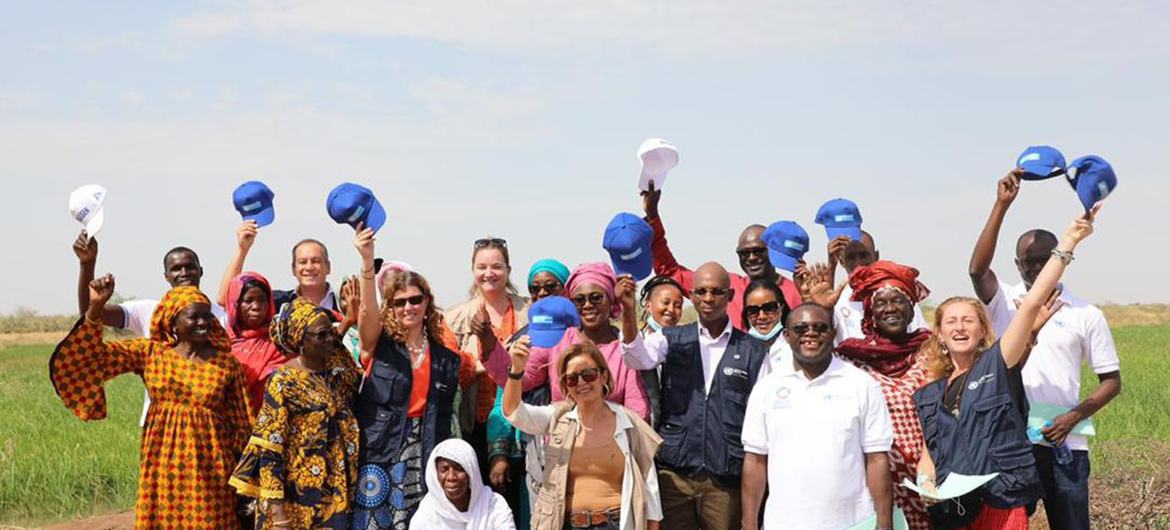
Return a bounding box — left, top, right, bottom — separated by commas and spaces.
503, 337, 662, 530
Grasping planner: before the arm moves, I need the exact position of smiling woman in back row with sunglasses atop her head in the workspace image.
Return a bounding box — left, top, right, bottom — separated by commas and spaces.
445, 236, 529, 469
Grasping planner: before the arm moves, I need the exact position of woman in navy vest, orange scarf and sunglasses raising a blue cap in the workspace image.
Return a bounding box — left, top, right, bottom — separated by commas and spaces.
352, 229, 507, 530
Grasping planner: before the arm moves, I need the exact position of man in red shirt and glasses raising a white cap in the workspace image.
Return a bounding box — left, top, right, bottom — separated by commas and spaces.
641, 183, 803, 329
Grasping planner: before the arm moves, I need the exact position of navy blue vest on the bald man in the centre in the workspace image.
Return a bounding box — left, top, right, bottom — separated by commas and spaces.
656, 324, 768, 488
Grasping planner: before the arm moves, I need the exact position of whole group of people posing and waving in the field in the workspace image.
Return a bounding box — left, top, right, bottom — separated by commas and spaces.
49, 170, 1121, 530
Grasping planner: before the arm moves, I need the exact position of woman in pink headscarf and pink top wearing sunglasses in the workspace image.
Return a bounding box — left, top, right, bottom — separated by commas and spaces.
483, 263, 649, 419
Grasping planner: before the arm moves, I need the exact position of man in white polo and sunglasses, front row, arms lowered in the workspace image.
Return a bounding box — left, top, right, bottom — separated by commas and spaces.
741, 303, 894, 530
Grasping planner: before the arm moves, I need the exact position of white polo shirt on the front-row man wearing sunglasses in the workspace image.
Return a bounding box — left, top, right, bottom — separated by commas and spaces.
743, 356, 894, 530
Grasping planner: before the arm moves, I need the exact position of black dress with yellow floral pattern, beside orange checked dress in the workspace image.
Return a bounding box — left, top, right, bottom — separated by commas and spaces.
230, 347, 362, 529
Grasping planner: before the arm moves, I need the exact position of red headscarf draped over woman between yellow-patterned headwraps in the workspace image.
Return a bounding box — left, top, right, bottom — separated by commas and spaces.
223, 273, 287, 417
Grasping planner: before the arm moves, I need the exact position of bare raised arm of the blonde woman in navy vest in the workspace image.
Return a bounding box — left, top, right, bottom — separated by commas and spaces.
999, 205, 1100, 369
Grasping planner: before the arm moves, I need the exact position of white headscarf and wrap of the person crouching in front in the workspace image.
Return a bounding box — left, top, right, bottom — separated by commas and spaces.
410, 438, 515, 530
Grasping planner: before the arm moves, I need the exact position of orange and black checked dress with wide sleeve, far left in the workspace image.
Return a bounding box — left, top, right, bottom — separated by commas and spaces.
49, 318, 250, 529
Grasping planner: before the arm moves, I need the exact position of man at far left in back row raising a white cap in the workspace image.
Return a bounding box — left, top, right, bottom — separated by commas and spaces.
74, 230, 227, 426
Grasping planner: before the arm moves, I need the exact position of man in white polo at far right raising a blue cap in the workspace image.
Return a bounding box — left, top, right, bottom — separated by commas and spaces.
969, 168, 1121, 529
